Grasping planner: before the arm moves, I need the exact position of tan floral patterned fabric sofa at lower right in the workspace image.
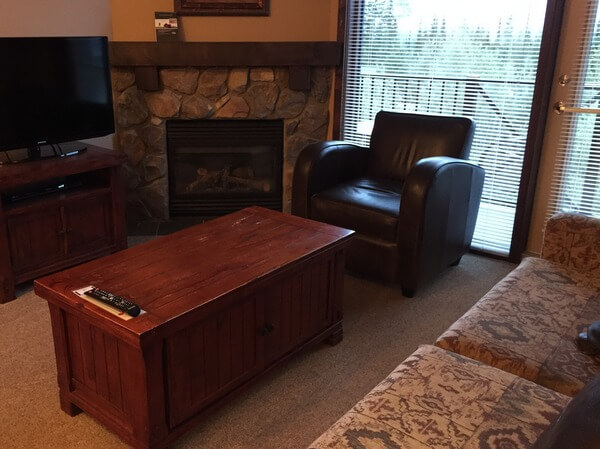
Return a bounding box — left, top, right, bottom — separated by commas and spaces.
310, 214, 600, 449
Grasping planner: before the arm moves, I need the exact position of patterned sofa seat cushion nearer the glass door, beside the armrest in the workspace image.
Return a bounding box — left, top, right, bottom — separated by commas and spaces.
436, 258, 600, 396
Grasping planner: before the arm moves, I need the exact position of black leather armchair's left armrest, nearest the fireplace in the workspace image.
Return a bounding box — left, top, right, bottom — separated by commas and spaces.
292, 140, 369, 217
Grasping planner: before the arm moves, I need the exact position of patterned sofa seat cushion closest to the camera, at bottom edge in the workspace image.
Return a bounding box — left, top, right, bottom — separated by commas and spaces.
310, 346, 569, 449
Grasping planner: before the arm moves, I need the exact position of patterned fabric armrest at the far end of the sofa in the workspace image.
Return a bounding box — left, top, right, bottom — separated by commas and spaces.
542, 213, 600, 276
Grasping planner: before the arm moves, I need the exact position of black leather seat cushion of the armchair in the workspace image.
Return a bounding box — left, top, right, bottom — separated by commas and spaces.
311, 178, 402, 241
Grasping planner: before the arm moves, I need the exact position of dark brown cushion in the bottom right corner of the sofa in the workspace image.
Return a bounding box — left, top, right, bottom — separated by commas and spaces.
532, 376, 600, 449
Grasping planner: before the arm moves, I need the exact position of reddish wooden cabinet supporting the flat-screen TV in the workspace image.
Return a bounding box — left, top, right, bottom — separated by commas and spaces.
0, 144, 127, 303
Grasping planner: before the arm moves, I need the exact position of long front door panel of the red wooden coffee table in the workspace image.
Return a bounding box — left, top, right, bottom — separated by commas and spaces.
166, 257, 335, 428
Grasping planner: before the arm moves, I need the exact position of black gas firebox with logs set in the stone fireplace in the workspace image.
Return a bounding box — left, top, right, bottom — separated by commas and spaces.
167, 119, 283, 217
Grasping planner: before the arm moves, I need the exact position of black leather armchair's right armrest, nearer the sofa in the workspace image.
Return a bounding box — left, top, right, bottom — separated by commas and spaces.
398, 156, 485, 290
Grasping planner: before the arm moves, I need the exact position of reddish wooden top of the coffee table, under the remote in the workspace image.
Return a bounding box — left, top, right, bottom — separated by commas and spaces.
35, 207, 353, 334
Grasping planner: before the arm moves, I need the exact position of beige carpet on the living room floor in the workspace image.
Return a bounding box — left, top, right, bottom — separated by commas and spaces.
0, 255, 514, 449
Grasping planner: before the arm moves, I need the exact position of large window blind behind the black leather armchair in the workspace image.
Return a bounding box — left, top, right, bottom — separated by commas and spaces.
342, 0, 546, 255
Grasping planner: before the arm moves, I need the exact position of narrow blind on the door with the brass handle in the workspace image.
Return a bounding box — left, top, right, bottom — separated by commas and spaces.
547, 0, 600, 217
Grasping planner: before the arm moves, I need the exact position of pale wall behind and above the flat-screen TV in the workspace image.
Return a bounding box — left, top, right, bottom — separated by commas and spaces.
0, 0, 113, 148
